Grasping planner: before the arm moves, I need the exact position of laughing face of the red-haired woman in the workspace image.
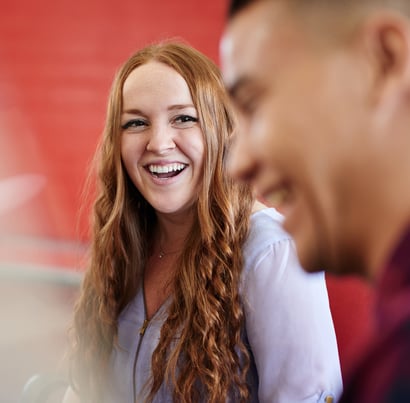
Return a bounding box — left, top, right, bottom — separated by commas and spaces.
121, 61, 205, 214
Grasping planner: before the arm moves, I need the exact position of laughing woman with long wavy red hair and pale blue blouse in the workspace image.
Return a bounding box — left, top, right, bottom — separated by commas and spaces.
65, 43, 341, 403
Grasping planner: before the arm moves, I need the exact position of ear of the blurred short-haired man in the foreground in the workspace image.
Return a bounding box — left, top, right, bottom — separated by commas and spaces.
361, 11, 410, 103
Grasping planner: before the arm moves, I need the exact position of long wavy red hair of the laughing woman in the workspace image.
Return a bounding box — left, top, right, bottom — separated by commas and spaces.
68, 42, 253, 403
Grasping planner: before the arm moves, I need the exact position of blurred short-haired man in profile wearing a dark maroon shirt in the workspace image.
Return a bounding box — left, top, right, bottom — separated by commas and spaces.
221, 0, 410, 402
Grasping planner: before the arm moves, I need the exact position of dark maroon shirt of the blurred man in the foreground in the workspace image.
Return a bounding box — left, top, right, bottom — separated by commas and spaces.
340, 228, 410, 403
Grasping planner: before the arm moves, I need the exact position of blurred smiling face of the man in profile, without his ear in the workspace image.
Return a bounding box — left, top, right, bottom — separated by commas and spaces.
221, 1, 374, 271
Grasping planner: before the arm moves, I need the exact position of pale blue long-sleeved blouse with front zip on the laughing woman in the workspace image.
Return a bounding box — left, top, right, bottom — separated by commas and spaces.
104, 209, 342, 403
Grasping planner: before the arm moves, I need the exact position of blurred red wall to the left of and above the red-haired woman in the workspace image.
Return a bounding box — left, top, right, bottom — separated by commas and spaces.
0, 0, 226, 272
